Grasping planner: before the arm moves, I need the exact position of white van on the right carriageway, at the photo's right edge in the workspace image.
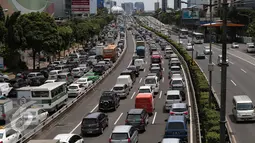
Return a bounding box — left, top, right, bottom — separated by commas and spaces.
232, 95, 255, 122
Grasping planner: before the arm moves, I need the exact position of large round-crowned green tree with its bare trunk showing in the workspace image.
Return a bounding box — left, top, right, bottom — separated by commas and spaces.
15, 12, 59, 69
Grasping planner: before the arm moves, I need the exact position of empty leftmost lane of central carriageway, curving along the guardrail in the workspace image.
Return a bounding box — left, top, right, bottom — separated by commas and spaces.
35, 33, 134, 139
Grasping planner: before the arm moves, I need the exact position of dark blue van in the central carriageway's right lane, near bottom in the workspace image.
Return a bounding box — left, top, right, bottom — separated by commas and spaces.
164, 115, 188, 142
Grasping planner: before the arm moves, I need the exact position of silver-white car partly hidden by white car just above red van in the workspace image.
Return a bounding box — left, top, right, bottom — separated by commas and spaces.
144, 76, 159, 94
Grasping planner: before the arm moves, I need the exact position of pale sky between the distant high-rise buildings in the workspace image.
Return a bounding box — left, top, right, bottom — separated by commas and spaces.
116, 0, 187, 10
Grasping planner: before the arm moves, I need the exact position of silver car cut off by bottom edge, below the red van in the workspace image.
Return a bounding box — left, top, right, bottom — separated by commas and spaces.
109, 125, 138, 143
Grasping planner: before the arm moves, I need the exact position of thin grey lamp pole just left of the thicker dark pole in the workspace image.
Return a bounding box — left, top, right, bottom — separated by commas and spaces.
208, 0, 213, 108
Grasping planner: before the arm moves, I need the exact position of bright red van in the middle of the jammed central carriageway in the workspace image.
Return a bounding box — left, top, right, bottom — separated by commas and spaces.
135, 93, 155, 115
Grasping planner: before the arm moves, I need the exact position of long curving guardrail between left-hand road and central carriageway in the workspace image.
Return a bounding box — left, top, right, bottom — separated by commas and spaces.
18, 31, 127, 143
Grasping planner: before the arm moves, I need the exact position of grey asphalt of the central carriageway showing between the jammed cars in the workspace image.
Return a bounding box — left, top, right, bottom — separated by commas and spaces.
29, 28, 192, 143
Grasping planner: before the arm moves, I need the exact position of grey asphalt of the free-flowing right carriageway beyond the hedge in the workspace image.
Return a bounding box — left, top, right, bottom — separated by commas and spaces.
165, 25, 255, 143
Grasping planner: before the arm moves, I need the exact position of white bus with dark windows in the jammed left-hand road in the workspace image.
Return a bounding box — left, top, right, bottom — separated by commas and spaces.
31, 82, 68, 112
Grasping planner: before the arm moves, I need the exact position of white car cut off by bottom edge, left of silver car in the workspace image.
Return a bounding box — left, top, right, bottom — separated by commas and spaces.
54, 134, 84, 143
